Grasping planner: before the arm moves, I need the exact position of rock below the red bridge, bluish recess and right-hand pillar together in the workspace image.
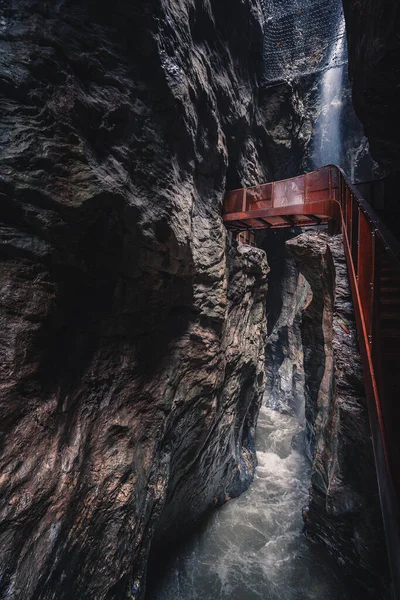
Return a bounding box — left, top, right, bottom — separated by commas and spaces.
262, 228, 390, 599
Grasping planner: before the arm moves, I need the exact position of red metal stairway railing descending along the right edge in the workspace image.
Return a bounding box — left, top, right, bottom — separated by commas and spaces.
338, 169, 400, 598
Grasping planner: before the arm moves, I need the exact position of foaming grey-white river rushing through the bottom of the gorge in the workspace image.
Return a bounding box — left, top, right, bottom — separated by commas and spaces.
147, 407, 356, 600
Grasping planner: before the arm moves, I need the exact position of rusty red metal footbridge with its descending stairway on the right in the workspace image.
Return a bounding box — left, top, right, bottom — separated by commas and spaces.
223, 165, 400, 599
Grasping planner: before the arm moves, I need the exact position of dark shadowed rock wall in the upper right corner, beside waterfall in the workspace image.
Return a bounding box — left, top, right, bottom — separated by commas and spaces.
343, 0, 400, 175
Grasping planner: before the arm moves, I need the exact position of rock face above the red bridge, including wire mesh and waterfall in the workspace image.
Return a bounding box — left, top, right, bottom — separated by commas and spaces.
255, 0, 386, 183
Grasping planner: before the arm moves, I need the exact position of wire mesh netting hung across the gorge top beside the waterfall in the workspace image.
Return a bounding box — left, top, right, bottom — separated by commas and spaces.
263, 0, 347, 86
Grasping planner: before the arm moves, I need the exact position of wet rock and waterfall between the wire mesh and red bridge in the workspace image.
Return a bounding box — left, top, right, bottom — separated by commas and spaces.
260, 67, 381, 182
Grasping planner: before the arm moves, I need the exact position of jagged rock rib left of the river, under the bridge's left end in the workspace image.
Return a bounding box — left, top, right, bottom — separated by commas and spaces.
148, 246, 269, 560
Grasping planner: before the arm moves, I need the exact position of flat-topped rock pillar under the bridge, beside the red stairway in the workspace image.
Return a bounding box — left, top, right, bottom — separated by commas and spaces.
286, 232, 389, 598
